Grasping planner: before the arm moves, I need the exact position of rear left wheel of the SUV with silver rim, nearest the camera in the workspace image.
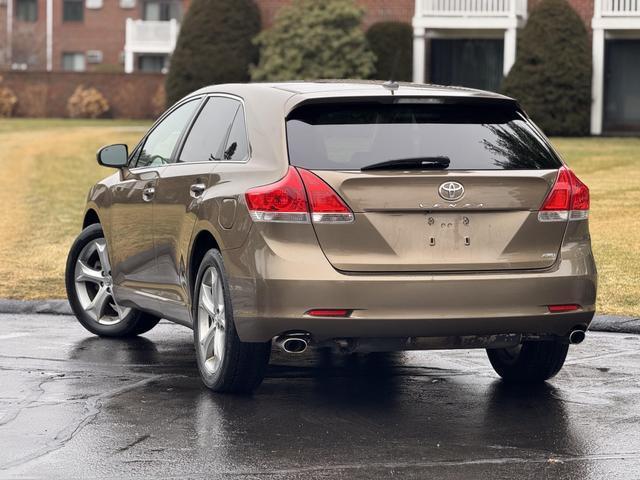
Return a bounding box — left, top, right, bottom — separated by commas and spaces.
192, 249, 271, 393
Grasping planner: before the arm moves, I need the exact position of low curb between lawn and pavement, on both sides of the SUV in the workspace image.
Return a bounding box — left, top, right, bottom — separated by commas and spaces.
0, 299, 640, 334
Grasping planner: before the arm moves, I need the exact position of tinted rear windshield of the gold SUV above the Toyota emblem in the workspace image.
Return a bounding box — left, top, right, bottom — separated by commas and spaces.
287, 103, 561, 170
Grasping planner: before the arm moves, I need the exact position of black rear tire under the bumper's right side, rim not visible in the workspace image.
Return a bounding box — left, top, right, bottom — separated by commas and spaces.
487, 341, 569, 383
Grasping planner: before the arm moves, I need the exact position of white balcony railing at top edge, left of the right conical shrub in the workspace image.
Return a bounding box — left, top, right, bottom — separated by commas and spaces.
416, 0, 528, 17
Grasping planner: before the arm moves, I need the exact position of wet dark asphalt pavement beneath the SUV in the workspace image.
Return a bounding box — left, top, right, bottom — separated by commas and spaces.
0, 315, 640, 479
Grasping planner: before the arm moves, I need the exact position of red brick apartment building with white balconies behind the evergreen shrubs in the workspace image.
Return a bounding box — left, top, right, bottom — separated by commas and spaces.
0, 0, 640, 134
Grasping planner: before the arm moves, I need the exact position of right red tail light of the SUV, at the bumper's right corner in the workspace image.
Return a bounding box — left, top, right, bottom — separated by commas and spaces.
538, 167, 589, 222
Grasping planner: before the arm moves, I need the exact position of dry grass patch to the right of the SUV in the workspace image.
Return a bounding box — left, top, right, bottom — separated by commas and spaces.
553, 138, 640, 316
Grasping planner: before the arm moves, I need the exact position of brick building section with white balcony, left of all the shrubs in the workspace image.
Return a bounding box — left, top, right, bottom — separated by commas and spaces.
0, 0, 189, 72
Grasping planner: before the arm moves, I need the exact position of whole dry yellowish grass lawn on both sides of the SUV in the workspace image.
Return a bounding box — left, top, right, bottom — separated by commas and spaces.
0, 119, 640, 316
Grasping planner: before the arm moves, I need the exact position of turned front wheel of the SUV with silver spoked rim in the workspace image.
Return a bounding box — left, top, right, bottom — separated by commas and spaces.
65, 224, 160, 338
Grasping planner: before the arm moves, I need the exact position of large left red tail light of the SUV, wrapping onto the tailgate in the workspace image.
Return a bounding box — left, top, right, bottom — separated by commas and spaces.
245, 167, 353, 223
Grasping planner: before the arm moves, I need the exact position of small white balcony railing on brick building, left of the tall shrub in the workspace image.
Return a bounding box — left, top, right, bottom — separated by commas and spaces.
125, 18, 179, 53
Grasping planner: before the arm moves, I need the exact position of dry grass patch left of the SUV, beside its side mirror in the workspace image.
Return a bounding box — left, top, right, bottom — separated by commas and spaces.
0, 120, 149, 299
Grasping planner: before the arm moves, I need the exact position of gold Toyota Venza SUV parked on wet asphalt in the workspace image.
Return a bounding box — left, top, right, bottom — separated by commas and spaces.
66, 81, 596, 392
